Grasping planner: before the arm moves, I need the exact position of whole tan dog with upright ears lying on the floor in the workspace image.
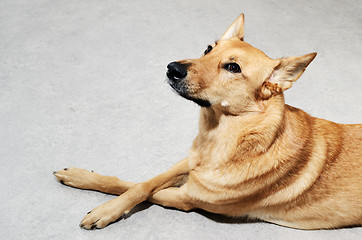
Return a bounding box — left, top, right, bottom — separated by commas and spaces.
54, 15, 362, 229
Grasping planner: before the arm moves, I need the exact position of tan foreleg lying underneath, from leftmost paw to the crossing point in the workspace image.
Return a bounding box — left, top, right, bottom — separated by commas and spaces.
53, 168, 136, 195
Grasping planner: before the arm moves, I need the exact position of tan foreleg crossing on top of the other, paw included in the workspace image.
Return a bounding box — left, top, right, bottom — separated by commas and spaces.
80, 158, 190, 229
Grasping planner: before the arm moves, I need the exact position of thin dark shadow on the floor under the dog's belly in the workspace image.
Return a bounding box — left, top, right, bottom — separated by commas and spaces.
124, 202, 264, 224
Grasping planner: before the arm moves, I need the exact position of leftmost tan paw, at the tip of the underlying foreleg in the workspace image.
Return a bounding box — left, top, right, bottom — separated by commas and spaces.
53, 168, 99, 189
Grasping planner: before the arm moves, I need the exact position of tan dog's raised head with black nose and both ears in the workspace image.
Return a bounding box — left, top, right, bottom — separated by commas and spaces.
167, 14, 316, 114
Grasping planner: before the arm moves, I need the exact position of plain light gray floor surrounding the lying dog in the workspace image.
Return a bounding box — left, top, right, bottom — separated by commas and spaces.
0, 0, 362, 239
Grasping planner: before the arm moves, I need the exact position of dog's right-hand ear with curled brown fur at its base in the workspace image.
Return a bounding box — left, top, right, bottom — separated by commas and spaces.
260, 52, 317, 99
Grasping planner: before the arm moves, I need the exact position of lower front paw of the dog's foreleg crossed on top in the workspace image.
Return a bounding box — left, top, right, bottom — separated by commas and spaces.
79, 199, 125, 230
